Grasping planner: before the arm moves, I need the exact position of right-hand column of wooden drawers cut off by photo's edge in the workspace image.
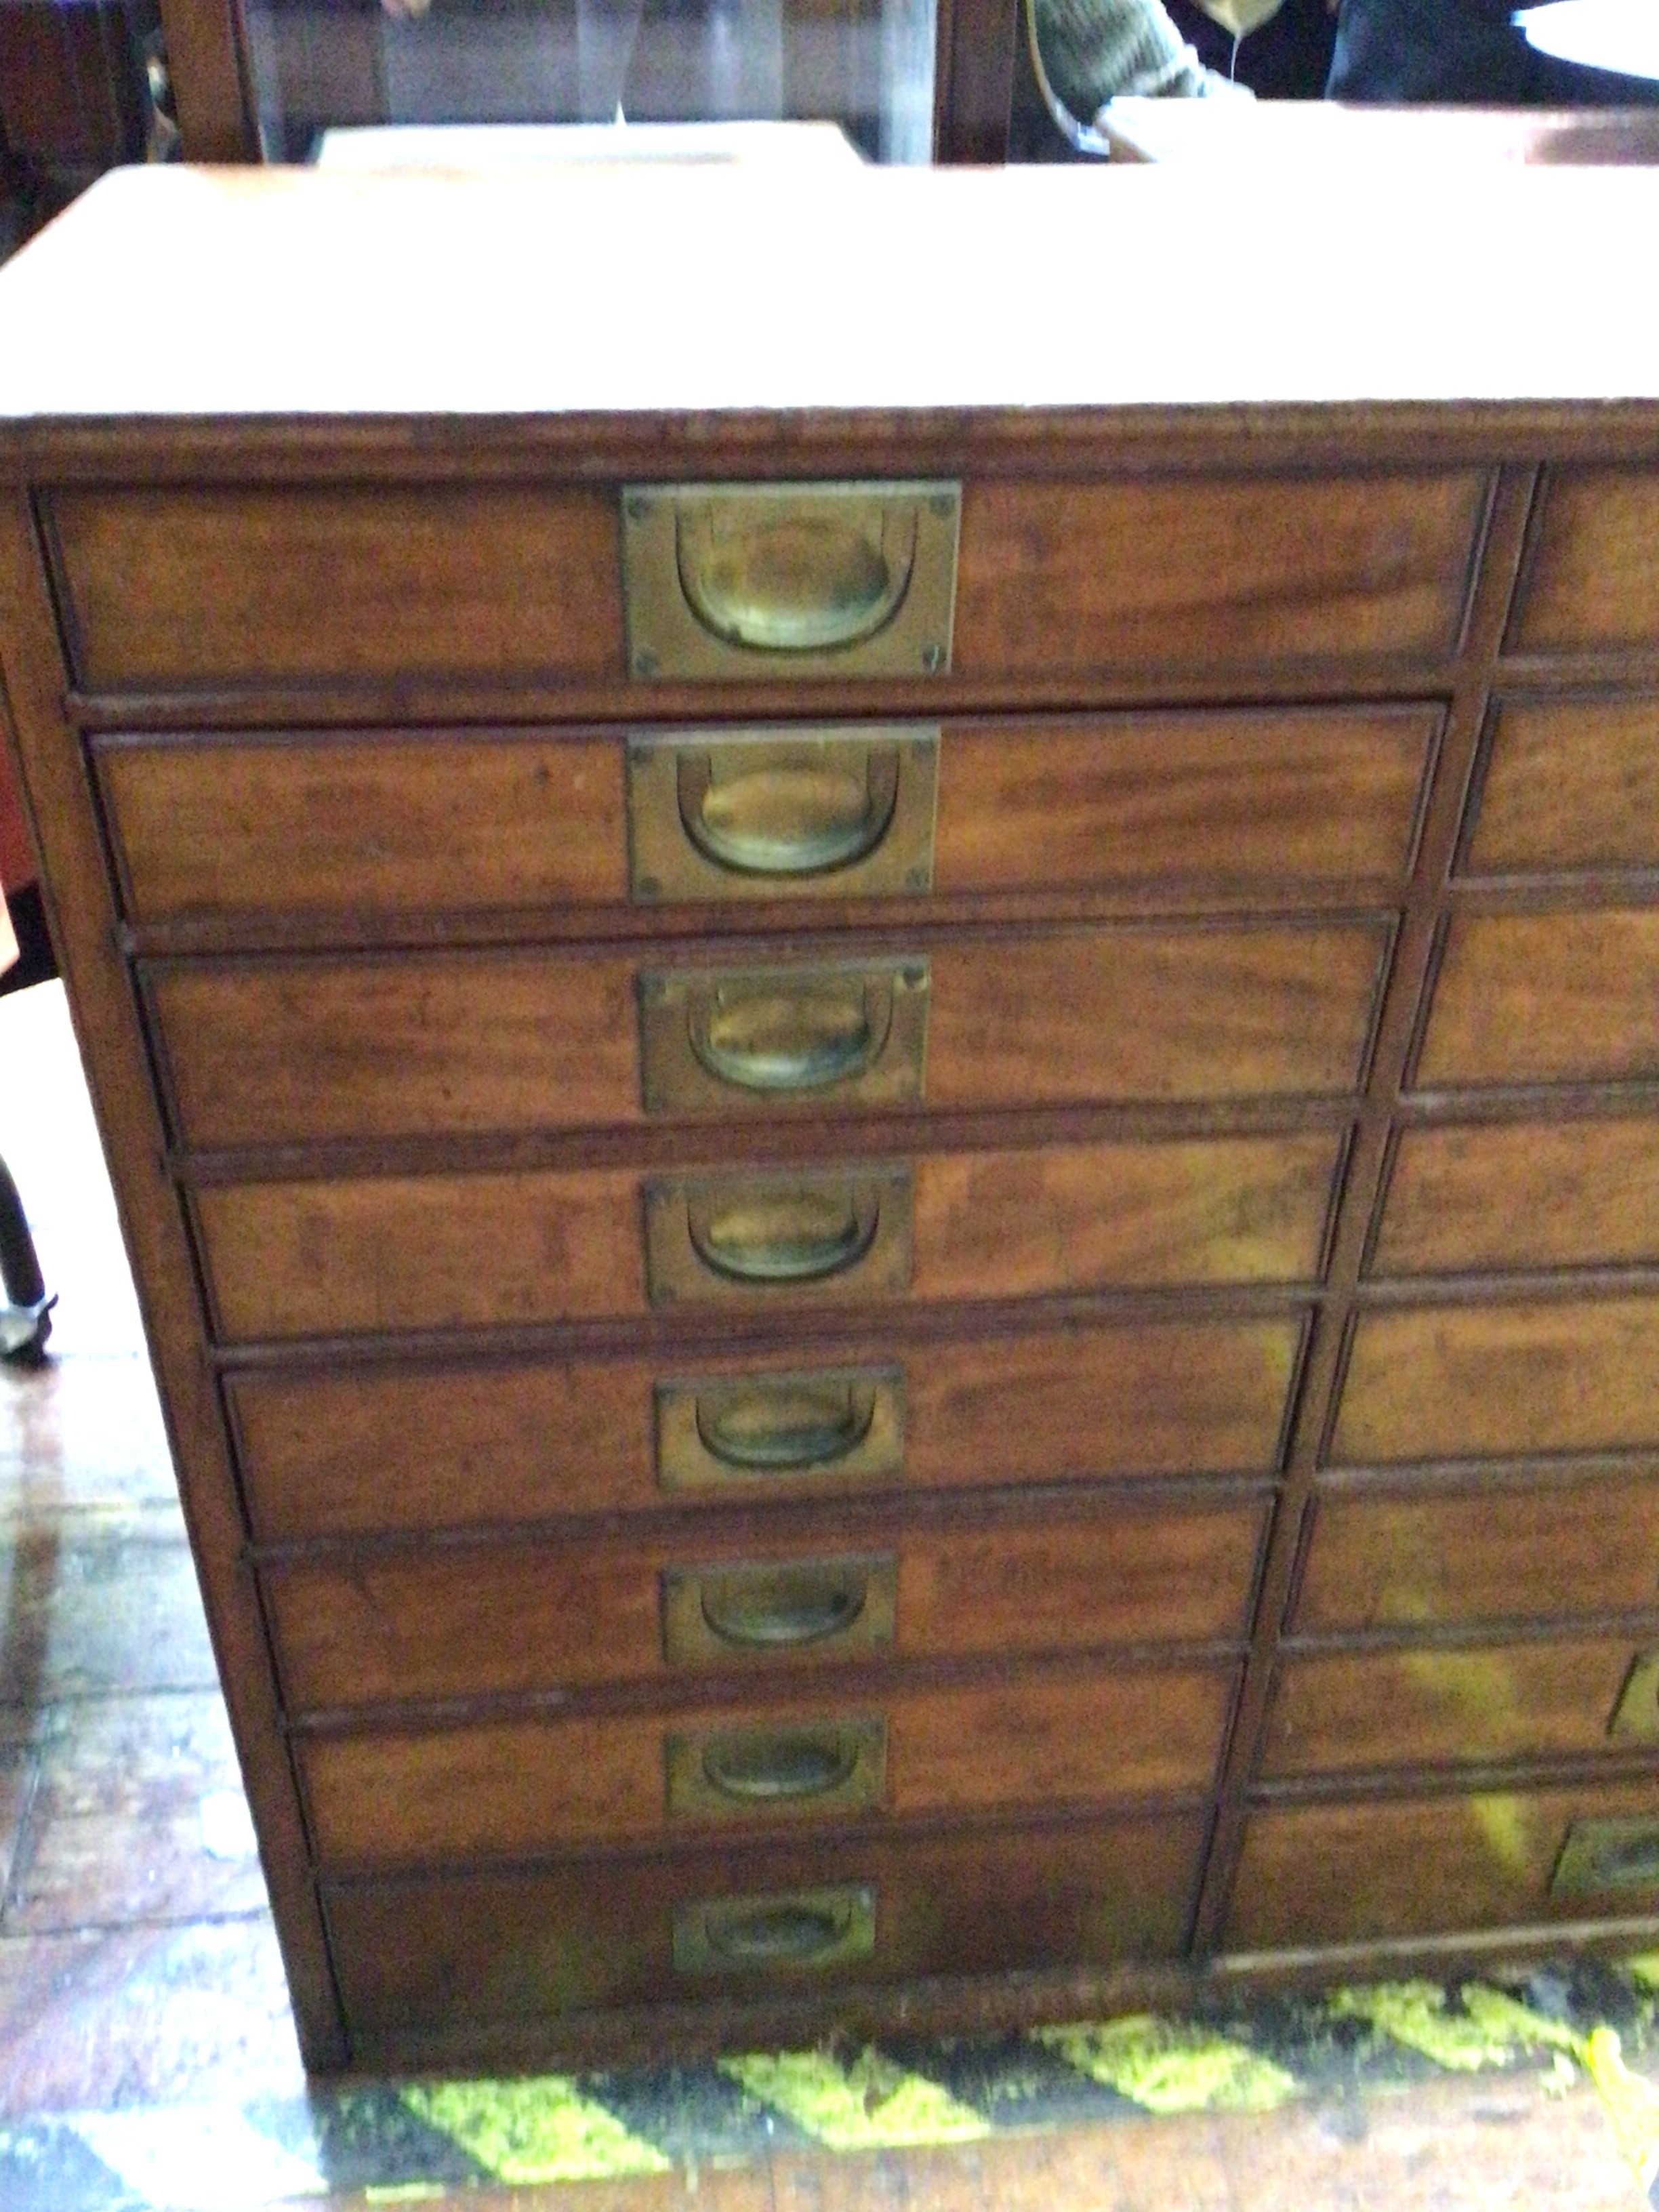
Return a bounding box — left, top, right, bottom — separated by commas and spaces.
1230, 632, 1659, 1949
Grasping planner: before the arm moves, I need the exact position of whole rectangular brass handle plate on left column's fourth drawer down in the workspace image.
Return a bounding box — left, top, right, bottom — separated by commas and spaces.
646, 1164, 916, 1305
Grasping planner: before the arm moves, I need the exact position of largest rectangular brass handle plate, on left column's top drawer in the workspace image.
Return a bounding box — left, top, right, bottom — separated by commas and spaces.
621, 483, 962, 684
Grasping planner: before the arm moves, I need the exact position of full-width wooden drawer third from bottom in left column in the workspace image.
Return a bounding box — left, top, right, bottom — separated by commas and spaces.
263, 1495, 1265, 1712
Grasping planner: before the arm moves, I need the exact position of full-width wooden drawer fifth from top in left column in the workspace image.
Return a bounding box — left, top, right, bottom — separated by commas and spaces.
228, 1316, 1300, 1542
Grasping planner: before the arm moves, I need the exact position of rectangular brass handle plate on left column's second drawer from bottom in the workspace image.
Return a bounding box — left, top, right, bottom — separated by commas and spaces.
663, 1715, 887, 1820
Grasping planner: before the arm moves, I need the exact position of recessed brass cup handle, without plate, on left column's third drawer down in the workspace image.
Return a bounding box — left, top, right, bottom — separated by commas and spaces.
686, 973, 894, 1090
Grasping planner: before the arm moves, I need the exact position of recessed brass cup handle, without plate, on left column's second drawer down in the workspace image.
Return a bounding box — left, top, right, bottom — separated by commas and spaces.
677, 743, 898, 876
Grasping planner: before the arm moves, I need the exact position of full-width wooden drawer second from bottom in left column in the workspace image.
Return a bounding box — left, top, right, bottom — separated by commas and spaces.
299, 1666, 1234, 1871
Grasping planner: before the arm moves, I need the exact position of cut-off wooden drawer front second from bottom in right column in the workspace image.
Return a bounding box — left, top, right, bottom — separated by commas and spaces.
1263, 1637, 1659, 1776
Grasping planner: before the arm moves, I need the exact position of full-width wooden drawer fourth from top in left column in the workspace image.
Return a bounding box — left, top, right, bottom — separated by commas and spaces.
194, 1132, 1338, 1343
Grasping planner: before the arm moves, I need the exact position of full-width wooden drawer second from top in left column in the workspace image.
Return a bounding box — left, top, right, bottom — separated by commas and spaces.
98, 705, 1440, 922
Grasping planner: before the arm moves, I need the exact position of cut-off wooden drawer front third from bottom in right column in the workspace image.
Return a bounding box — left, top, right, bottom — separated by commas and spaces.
1292, 1475, 1659, 1635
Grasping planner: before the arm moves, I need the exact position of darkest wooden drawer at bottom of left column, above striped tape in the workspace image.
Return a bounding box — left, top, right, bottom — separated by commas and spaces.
325, 1816, 1204, 2033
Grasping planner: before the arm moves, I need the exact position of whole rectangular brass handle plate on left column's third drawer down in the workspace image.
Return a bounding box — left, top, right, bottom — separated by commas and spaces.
639, 960, 929, 1120
